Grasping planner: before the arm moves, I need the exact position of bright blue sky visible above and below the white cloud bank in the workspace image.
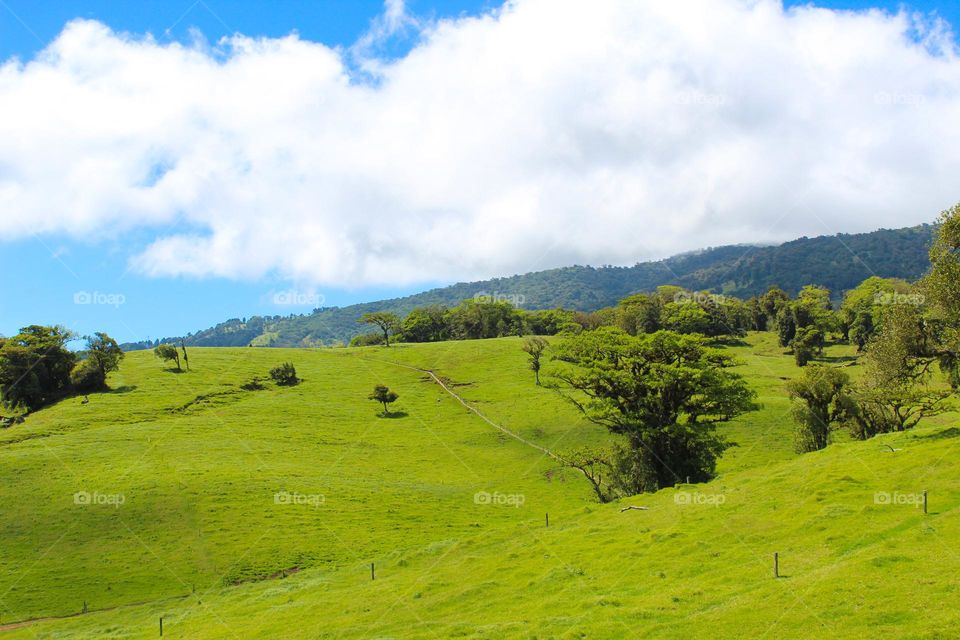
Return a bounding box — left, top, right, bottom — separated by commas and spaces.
0, 0, 960, 341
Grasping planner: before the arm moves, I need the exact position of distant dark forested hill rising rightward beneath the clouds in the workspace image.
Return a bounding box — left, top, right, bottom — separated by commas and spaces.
123, 225, 935, 350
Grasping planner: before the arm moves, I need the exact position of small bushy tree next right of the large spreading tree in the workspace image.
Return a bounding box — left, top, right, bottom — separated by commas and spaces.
787, 365, 851, 453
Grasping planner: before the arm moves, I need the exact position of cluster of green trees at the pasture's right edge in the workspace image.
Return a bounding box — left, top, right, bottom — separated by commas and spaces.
780, 208, 960, 452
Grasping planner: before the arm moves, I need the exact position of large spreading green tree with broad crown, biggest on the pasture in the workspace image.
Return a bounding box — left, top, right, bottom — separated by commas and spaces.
551, 327, 756, 491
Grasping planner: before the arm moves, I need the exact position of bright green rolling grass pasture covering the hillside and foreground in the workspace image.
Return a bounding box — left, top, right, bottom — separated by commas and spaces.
0, 334, 960, 639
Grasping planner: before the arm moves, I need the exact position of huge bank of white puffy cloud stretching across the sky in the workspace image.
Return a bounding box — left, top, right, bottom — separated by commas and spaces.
0, 0, 960, 285
